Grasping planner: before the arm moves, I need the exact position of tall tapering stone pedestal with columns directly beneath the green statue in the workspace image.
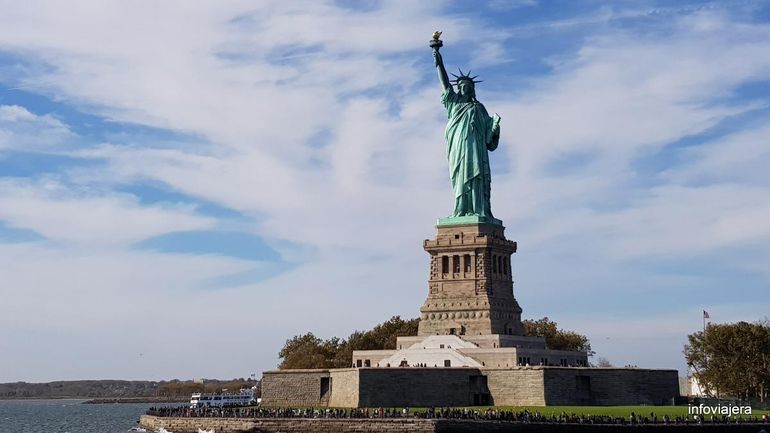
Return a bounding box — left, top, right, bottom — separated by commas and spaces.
418, 221, 524, 336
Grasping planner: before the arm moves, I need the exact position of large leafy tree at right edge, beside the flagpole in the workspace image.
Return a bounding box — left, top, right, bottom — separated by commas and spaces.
683, 320, 770, 403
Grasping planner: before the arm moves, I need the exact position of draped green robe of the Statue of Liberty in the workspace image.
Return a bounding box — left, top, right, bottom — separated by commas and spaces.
441, 86, 500, 218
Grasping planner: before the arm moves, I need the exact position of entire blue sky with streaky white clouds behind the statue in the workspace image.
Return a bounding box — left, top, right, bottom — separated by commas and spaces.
0, 0, 770, 382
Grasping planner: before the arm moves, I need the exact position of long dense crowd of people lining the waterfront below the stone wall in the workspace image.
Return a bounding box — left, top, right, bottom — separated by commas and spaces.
147, 406, 769, 425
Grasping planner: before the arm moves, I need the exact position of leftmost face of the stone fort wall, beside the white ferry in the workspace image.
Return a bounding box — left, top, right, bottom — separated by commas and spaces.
262, 370, 333, 407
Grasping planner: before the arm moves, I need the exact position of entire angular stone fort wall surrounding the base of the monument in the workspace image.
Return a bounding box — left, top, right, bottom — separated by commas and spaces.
262, 366, 679, 407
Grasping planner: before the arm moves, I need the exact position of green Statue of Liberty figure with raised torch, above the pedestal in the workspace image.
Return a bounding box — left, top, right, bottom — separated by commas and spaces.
430, 32, 501, 224
